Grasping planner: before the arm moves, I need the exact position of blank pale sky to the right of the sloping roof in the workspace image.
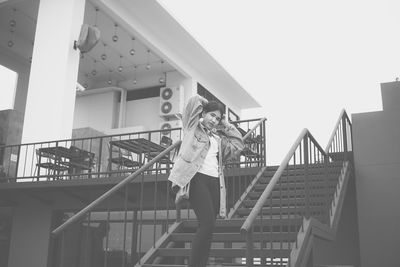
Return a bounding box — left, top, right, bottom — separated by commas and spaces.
159, 0, 400, 164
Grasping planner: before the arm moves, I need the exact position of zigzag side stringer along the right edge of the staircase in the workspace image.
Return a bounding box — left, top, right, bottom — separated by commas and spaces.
287, 162, 351, 267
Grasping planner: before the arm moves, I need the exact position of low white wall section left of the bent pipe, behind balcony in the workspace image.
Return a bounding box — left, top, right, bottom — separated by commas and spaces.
74, 91, 117, 131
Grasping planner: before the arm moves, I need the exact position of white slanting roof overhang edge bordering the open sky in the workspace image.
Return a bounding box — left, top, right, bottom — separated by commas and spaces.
93, 0, 260, 109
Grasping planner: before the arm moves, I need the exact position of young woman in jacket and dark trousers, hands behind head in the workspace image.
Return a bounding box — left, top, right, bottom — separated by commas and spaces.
168, 96, 243, 267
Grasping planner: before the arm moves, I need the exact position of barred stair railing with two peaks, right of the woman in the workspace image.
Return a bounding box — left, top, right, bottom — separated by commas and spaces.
241, 110, 352, 266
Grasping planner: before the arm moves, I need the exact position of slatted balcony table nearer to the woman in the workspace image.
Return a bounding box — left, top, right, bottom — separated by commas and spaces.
109, 138, 165, 170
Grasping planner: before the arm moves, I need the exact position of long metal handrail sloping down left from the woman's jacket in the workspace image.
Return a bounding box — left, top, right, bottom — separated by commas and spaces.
51, 140, 182, 236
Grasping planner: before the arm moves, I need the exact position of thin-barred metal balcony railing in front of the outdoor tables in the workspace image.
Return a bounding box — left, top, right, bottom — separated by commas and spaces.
0, 119, 266, 184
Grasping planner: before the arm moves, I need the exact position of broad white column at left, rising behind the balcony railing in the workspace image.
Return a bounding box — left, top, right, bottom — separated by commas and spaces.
22, 0, 85, 143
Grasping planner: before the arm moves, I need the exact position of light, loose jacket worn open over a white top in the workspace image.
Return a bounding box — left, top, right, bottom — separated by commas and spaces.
168, 95, 244, 218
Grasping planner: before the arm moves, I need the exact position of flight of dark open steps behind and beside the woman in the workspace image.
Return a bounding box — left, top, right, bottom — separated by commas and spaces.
136, 164, 341, 267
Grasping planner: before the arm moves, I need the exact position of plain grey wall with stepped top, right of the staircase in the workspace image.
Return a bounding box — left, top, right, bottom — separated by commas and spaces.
352, 82, 400, 267
